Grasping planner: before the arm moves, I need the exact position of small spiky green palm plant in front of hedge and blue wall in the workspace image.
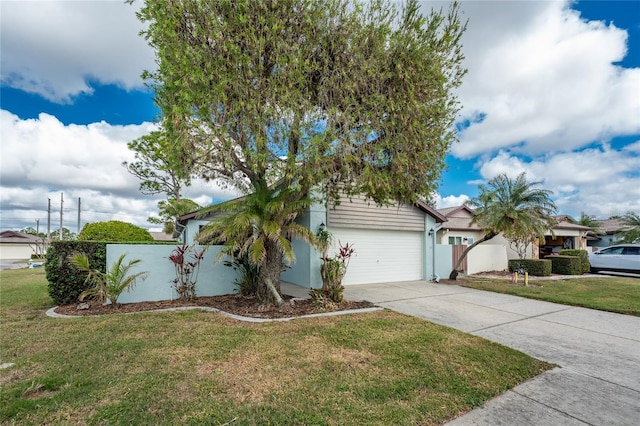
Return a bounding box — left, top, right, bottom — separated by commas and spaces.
69, 253, 147, 308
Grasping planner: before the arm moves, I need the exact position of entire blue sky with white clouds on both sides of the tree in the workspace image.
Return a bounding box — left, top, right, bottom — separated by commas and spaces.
0, 0, 640, 232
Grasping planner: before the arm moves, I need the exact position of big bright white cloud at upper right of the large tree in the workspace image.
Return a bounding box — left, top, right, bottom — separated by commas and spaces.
452, 1, 640, 158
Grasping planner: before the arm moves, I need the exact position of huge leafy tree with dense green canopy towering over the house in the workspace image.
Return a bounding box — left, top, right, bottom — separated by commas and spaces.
139, 0, 465, 302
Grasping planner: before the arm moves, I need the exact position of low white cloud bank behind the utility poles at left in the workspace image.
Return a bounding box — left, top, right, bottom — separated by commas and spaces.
0, 110, 240, 231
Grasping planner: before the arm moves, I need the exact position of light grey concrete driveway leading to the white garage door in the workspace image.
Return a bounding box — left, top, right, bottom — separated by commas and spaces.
345, 281, 640, 426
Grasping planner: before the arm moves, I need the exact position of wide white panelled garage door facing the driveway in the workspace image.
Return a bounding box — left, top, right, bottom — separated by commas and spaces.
329, 228, 424, 285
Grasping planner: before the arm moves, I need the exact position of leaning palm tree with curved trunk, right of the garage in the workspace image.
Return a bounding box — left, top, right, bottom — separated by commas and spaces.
449, 173, 557, 280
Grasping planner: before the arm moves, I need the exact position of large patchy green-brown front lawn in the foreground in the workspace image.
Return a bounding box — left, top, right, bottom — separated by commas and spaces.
0, 269, 551, 425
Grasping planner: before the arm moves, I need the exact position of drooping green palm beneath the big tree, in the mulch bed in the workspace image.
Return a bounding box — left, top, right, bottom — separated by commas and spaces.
197, 184, 315, 306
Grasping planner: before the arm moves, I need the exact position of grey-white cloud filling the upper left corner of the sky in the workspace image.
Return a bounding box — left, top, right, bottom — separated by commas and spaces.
0, 0, 155, 102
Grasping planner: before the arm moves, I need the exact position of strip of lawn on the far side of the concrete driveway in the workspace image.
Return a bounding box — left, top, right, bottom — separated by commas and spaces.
460, 276, 640, 316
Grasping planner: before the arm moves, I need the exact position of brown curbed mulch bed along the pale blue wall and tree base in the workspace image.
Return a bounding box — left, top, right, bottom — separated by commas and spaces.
55, 294, 374, 318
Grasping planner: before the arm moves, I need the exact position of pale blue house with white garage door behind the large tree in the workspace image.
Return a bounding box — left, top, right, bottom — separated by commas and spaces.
176, 197, 450, 288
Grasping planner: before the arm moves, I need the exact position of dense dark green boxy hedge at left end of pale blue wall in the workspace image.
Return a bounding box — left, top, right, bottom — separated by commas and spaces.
44, 241, 107, 305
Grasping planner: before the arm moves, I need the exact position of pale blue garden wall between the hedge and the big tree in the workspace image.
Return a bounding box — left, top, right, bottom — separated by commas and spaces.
107, 244, 238, 303
